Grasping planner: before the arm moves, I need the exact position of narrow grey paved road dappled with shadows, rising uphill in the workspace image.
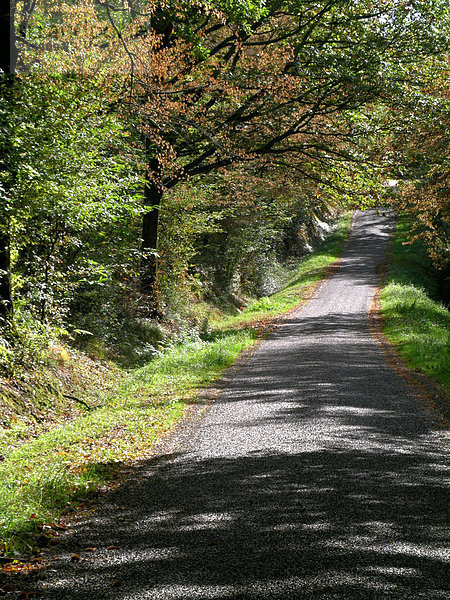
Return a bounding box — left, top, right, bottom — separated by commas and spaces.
34, 211, 450, 600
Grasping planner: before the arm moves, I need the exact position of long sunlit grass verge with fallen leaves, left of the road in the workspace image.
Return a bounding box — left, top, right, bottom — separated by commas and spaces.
0, 216, 350, 555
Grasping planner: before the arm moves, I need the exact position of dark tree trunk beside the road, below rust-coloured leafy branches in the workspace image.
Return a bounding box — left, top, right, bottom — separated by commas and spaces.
141, 149, 163, 302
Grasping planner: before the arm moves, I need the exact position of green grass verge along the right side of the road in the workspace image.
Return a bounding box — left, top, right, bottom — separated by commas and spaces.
380, 217, 450, 392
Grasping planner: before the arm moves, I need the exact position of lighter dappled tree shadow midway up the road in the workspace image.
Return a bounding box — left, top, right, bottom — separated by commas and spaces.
213, 314, 438, 444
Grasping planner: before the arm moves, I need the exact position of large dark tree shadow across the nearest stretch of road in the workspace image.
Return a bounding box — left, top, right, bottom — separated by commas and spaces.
33, 441, 448, 600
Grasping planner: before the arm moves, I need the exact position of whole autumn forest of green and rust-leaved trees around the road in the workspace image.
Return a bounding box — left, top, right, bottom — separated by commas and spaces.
0, 0, 450, 556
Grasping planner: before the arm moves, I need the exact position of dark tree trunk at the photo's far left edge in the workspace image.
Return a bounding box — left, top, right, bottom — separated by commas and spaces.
0, 2, 17, 321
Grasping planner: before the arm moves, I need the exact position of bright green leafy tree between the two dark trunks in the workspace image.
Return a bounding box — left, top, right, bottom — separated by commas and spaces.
9, 77, 142, 324
